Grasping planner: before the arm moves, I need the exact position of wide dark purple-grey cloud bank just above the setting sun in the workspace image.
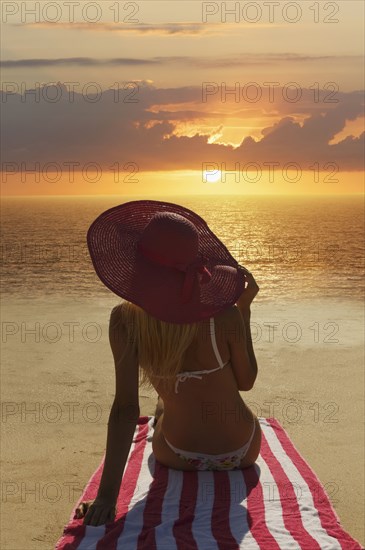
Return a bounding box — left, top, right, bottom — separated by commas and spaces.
2, 82, 364, 171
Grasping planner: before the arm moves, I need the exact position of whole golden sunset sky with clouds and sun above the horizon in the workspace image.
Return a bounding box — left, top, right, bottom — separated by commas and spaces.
1, 0, 364, 195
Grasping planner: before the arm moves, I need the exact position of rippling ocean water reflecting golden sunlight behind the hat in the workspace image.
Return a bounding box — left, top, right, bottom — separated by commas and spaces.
1, 195, 364, 302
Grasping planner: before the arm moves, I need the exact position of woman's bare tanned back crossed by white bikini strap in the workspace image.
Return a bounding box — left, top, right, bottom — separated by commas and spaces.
146, 306, 252, 454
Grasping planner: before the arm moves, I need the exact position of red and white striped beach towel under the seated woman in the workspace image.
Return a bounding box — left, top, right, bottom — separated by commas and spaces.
55, 416, 362, 550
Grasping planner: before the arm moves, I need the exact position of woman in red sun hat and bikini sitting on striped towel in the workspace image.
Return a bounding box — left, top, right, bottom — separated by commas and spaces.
76, 200, 261, 526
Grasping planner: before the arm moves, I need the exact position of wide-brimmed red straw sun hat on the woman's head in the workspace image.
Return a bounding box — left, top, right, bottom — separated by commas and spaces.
87, 200, 246, 323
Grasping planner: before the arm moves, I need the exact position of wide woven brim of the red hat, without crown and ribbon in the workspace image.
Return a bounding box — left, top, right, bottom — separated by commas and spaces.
87, 200, 244, 323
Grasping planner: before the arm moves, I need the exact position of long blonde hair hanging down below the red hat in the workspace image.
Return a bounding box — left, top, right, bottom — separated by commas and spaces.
122, 300, 200, 390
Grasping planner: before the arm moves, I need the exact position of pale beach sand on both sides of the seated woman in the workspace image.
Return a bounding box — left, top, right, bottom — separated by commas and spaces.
0, 295, 365, 550
